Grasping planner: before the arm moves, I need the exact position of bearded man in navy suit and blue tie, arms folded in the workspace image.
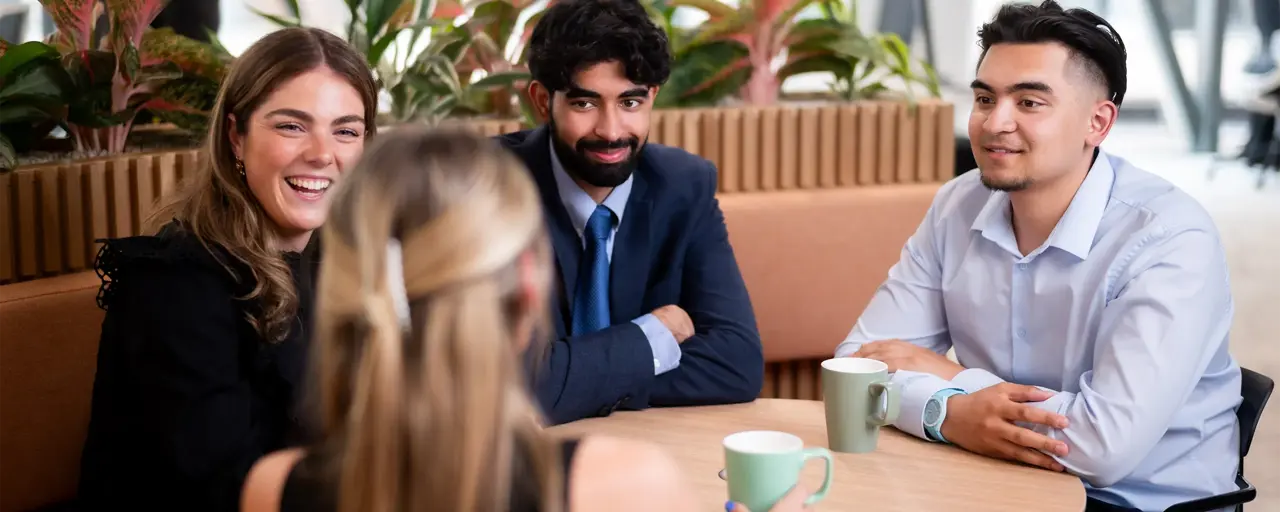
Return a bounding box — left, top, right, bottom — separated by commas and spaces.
499, 0, 764, 424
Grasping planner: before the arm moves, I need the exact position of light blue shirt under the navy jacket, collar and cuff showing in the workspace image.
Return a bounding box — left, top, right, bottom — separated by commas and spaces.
550, 140, 680, 375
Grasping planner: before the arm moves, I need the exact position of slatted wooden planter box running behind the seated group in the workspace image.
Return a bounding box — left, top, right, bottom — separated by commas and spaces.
0, 101, 955, 284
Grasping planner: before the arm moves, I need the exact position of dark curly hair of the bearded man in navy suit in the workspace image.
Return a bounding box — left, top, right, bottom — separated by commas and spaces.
529, 0, 671, 91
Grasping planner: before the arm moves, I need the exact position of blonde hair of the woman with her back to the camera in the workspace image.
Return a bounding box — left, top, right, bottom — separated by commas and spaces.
314, 128, 563, 512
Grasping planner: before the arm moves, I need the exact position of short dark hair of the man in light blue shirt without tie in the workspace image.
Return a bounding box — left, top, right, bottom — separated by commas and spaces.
978, 0, 1129, 106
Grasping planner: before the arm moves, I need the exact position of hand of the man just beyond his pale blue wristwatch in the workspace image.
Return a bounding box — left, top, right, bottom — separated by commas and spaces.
942, 383, 1068, 471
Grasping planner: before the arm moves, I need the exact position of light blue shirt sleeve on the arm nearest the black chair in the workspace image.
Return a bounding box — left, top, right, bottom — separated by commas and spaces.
952, 229, 1233, 488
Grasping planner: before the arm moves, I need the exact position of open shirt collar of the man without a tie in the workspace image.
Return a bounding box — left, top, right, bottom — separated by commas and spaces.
972, 150, 1115, 260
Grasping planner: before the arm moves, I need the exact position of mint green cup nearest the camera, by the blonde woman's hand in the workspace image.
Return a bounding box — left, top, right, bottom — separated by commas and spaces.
724, 430, 833, 512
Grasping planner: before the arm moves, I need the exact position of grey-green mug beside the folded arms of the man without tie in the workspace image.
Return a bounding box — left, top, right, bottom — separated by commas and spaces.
822, 357, 901, 453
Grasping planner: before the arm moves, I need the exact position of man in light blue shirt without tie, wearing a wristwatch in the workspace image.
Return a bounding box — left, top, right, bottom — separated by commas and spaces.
836, 1, 1242, 511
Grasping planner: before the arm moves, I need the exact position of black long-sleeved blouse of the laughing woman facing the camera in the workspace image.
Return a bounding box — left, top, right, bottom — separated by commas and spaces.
78, 224, 319, 511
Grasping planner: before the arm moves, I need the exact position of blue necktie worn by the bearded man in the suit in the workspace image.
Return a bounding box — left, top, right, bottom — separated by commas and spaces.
572, 206, 613, 335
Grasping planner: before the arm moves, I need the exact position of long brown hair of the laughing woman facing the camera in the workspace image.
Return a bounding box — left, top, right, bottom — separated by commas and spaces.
146, 28, 378, 343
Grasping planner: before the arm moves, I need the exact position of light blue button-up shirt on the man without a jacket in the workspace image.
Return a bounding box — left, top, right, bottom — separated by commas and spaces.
836, 151, 1240, 511
